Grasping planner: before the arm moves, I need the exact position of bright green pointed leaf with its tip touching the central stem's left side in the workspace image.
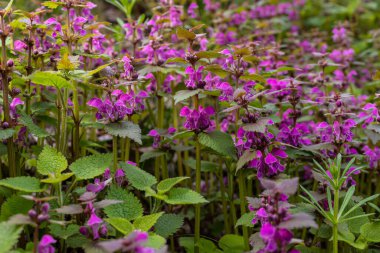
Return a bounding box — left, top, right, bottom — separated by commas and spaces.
165, 188, 208, 205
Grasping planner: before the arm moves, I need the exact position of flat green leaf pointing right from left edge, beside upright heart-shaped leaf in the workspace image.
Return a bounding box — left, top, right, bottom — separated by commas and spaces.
0, 177, 43, 192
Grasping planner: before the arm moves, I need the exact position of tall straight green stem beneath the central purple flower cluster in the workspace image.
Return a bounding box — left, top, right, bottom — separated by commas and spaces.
194, 136, 201, 253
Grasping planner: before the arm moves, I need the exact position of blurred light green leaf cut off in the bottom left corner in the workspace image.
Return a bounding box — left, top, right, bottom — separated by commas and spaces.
0, 222, 22, 253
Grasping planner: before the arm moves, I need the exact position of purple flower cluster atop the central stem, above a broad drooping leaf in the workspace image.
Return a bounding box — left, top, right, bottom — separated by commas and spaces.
179, 106, 215, 132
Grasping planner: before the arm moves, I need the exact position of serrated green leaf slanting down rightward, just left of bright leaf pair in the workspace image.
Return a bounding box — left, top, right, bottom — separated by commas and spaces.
121, 163, 157, 191
